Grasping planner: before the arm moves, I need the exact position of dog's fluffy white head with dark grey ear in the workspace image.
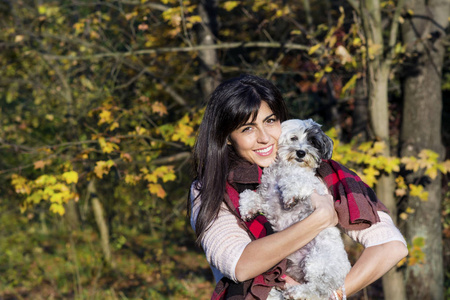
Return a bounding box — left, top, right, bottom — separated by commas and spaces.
278, 119, 333, 169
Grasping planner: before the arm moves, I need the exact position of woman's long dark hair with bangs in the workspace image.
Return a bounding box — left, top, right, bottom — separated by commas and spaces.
188, 75, 287, 241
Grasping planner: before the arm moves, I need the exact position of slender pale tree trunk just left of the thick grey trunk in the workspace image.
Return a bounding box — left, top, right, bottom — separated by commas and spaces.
360, 0, 406, 300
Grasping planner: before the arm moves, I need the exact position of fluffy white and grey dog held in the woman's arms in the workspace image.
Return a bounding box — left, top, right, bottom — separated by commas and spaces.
239, 119, 351, 299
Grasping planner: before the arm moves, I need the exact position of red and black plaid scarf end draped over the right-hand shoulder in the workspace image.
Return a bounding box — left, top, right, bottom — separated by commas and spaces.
317, 159, 388, 230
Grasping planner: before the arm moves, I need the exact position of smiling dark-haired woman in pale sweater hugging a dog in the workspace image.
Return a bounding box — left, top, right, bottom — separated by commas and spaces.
188, 75, 407, 299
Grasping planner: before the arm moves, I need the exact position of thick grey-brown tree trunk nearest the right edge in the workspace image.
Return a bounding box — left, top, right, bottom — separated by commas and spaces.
400, 0, 450, 299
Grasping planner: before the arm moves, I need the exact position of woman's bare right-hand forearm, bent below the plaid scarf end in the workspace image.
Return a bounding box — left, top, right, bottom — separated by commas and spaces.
345, 241, 408, 295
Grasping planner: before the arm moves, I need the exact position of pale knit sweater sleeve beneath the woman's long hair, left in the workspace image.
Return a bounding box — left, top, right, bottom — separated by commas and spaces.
191, 186, 251, 282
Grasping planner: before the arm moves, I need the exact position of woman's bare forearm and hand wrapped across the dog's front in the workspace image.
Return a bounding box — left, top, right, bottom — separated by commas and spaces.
235, 194, 338, 281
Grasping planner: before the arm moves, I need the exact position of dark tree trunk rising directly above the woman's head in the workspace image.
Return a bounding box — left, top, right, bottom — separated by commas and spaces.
197, 0, 221, 97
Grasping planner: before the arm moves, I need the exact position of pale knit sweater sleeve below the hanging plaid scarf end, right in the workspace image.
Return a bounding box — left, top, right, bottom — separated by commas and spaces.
346, 211, 406, 248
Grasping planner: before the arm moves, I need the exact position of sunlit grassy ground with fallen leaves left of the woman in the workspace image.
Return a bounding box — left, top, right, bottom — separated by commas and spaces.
0, 215, 213, 300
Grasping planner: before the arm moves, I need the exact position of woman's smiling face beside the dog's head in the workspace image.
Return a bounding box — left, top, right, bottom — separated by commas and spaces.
230, 101, 281, 168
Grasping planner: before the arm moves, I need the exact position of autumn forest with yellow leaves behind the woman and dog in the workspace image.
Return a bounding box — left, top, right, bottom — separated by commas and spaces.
0, 0, 450, 300
